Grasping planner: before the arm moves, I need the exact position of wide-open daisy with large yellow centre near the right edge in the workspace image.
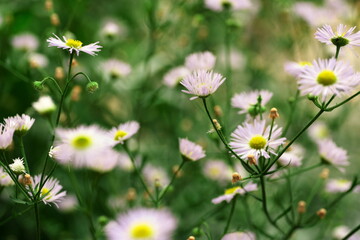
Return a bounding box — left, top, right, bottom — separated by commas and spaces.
298, 58, 359, 101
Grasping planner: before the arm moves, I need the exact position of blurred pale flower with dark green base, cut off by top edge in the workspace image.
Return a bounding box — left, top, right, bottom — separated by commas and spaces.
205, 0, 252, 12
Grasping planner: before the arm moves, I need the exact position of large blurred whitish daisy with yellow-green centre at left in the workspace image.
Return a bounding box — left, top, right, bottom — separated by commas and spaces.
51, 125, 112, 167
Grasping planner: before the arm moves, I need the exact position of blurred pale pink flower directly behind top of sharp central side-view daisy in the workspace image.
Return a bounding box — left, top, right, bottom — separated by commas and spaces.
185, 51, 216, 71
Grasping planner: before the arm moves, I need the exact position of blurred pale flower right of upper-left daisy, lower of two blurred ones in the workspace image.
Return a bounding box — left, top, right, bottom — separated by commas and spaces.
102, 59, 131, 79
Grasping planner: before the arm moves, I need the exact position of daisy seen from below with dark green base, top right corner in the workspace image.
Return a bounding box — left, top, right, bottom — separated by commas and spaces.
315, 24, 360, 47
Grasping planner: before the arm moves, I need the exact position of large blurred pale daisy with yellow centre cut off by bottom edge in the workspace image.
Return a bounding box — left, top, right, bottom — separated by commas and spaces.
105, 208, 177, 240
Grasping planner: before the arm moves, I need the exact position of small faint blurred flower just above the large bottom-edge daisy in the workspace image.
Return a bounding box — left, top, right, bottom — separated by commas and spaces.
142, 164, 170, 187
